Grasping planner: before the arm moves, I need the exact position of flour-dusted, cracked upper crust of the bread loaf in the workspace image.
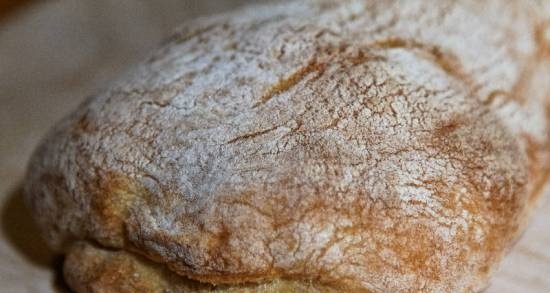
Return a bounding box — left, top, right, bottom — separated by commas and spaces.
25, 0, 550, 292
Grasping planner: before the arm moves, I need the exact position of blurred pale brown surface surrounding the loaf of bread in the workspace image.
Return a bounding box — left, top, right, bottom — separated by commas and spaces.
0, 0, 550, 293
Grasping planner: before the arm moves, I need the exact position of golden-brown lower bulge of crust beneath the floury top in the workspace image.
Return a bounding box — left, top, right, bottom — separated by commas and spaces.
63, 242, 341, 293
